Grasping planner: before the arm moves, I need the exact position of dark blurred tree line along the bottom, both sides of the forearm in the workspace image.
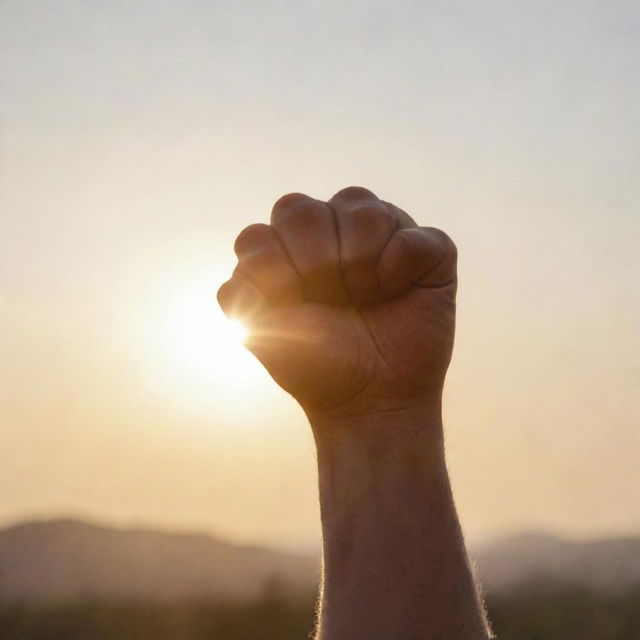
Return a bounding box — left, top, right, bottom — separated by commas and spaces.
0, 585, 640, 640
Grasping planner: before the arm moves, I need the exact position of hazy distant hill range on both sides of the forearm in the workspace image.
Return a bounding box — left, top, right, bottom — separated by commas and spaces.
0, 520, 640, 603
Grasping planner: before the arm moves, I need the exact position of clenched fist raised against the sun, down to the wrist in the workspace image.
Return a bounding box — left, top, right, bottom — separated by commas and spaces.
218, 187, 456, 418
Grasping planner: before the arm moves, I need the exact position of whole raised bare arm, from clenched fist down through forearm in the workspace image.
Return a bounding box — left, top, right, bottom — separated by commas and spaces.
218, 187, 489, 640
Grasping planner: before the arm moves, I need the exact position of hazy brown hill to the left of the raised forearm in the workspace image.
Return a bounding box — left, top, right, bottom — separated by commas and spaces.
0, 520, 319, 603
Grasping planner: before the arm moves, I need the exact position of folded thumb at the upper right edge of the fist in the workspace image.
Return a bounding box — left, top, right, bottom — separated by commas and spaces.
378, 227, 458, 298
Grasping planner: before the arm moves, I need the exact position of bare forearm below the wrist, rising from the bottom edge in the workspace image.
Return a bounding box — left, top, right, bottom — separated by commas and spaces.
311, 407, 488, 640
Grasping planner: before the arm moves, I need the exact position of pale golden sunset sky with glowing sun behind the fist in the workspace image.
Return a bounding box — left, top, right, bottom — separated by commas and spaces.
0, 0, 640, 548
